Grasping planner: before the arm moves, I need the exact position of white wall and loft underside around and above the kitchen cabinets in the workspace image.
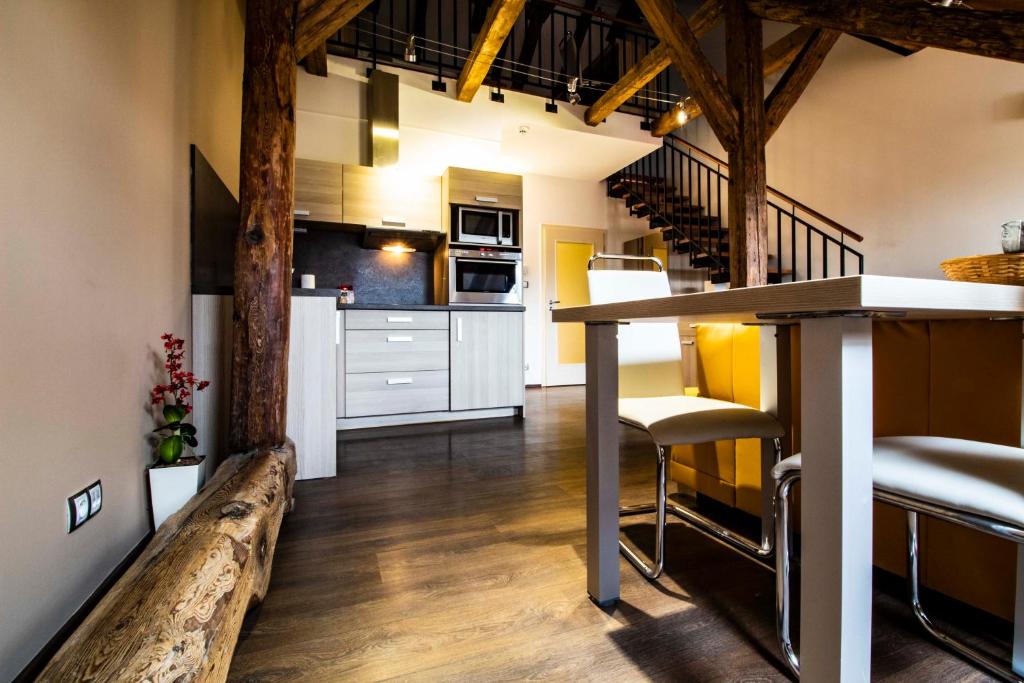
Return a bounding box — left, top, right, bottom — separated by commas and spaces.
296, 57, 658, 384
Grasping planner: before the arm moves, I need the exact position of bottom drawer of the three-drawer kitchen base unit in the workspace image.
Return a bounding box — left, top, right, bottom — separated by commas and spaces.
345, 370, 449, 418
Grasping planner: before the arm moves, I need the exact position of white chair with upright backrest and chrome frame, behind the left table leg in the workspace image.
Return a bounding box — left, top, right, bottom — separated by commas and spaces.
587, 254, 785, 579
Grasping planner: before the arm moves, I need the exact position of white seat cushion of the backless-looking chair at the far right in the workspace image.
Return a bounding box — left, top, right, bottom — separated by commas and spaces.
772, 436, 1024, 526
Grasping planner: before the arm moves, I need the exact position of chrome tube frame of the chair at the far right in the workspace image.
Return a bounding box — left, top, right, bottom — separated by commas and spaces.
775, 470, 1024, 682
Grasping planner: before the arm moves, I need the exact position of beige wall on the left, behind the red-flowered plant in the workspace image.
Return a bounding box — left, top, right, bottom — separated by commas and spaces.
0, 0, 242, 680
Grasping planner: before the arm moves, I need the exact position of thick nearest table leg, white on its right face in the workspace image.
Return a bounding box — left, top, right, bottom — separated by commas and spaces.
800, 317, 873, 683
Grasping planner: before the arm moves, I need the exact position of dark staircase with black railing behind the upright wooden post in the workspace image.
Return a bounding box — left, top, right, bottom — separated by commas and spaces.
607, 135, 864, 284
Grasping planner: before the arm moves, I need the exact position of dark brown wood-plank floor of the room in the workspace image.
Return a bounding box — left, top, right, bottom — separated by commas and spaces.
229, 388, 989, 681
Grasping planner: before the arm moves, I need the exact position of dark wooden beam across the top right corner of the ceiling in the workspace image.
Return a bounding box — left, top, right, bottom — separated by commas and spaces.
746, 0, 1024, 61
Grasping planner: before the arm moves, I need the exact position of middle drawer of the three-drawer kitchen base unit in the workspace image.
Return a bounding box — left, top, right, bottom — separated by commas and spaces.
345, 330, 449, 375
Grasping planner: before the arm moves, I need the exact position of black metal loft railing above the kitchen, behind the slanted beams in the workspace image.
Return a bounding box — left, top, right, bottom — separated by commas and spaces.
327, 0, 684, 121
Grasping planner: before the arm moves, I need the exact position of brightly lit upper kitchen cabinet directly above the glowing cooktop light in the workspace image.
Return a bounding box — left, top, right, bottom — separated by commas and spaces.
342, 165, 442, 231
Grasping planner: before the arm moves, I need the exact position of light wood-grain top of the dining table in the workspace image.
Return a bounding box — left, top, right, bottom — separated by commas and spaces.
551, 275, 1024, 323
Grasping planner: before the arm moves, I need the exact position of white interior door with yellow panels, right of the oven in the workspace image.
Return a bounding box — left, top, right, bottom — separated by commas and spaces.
543, 225, 606, 386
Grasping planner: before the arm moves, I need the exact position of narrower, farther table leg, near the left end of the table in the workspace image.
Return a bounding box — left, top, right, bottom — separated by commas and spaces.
587, 323, 618, 606
